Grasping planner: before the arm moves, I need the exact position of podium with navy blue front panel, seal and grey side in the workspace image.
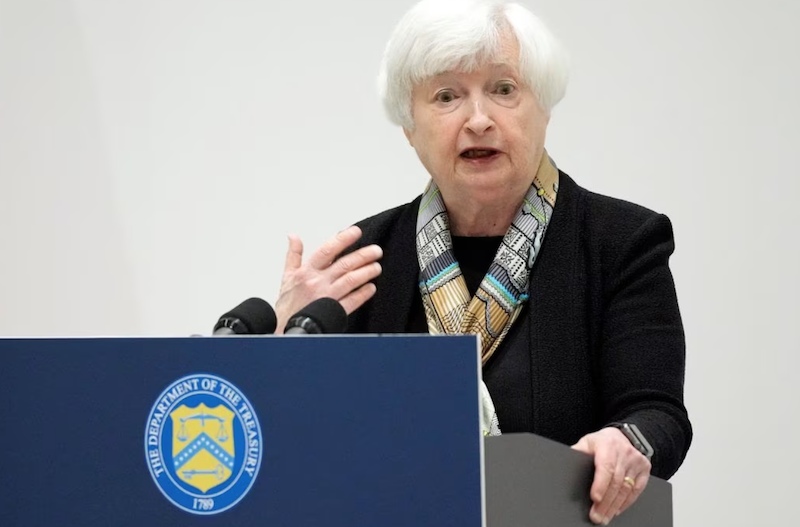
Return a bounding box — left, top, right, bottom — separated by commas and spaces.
0, 335, 672, 527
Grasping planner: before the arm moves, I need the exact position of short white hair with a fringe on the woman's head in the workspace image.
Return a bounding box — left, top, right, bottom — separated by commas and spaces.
378, 0, 569, 130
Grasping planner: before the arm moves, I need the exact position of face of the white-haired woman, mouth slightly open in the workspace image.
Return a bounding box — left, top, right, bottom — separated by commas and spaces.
404, 32, 549, 206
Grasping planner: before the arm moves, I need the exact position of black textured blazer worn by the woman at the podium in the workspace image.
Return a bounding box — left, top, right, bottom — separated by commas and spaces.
348, 172, 692, 478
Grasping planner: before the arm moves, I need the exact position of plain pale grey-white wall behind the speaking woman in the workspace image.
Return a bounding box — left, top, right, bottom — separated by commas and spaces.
0, 0, 800, 527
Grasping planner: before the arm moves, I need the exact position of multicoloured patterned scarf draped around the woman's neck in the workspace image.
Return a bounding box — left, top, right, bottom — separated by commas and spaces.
417, 152, 558, 364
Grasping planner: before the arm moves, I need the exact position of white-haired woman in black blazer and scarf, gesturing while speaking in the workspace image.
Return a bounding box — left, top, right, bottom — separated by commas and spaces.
277, 0, 692, 524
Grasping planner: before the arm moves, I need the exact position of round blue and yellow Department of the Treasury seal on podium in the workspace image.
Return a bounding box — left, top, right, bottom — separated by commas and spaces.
144, 374, 263, 514
